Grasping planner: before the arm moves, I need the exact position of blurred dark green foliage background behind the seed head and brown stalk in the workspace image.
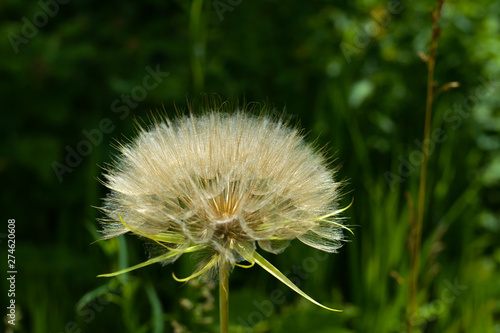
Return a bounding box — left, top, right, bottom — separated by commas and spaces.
0, 0, 500, 333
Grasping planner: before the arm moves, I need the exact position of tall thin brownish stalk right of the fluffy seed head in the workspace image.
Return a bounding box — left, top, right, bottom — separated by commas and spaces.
409, 0, 444, 332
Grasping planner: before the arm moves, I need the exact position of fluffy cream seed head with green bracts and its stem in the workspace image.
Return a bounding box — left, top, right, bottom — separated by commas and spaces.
96, 102, 349, 332
